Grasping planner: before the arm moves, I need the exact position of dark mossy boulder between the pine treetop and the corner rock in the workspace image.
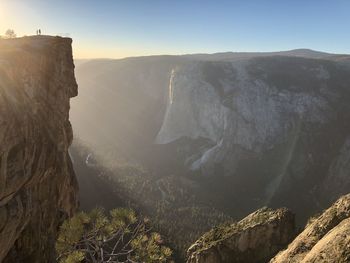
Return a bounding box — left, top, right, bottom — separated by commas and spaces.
187, 208, 295, 263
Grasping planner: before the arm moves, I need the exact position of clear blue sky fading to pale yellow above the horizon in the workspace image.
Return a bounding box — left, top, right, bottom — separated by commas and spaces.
0, 0, 350, 58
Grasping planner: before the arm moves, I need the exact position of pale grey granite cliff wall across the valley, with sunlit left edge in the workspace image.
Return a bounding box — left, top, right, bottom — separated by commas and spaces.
156, 57, 350, 203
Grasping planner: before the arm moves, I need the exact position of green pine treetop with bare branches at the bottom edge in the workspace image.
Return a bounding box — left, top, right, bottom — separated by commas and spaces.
56, 208, 172, 263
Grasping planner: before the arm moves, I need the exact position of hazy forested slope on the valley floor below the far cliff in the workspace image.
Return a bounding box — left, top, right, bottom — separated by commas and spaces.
71, 139, 232, 262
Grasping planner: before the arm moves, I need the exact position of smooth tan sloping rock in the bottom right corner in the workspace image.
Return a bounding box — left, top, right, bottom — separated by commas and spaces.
270, 194, 350, 263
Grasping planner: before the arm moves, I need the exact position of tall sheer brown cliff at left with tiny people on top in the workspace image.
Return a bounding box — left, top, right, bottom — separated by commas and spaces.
0, 36, 77, 262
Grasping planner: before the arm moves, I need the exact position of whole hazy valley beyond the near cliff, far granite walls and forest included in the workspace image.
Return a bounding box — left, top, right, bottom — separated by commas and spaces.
71, 50, 350, 260
